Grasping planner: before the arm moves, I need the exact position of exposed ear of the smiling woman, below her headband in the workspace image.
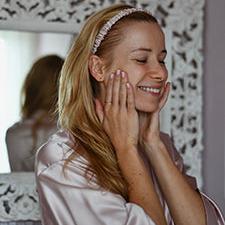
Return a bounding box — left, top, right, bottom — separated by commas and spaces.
88, 55, 105, 82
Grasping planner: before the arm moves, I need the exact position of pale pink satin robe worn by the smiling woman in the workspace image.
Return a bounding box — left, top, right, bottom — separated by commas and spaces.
35, 130, 225, 225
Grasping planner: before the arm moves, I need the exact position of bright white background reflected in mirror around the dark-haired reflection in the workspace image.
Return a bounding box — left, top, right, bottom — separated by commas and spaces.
0, 31, 73, 173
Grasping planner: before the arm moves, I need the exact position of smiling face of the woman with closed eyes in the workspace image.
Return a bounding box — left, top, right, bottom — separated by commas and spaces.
105, 22, 168, 112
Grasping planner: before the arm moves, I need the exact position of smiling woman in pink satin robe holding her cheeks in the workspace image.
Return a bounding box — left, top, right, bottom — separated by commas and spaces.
36, 5, 224, 225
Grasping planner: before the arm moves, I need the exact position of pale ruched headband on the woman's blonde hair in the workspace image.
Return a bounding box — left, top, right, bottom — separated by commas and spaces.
92, 8, 150, 54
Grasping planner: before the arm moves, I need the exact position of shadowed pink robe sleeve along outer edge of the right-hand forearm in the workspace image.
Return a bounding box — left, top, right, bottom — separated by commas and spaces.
164, 135, 225, 225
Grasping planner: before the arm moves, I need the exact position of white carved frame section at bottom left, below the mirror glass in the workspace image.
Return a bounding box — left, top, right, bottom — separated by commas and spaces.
0, 173, 40, 222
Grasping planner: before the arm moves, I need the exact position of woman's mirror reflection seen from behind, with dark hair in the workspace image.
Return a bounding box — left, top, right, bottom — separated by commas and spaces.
6, 55, 64, 172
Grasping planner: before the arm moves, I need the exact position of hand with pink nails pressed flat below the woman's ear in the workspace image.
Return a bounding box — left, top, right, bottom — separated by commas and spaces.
95, 70, 139, 152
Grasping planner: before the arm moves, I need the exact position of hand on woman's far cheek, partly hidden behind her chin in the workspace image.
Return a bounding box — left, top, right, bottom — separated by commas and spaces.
140, 82, 170, 148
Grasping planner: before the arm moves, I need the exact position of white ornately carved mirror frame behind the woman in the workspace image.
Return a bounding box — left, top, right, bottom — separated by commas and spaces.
0, 0, 205, 221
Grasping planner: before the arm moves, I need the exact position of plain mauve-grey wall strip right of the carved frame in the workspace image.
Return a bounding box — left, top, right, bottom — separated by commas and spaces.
203, 0, 225, 214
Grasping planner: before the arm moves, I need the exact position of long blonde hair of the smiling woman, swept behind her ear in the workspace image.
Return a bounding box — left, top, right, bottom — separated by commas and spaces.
58, 5, 157, 199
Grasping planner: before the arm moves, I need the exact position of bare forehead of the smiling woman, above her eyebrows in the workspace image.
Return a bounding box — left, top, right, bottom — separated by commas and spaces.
118, 22, 165, 51
